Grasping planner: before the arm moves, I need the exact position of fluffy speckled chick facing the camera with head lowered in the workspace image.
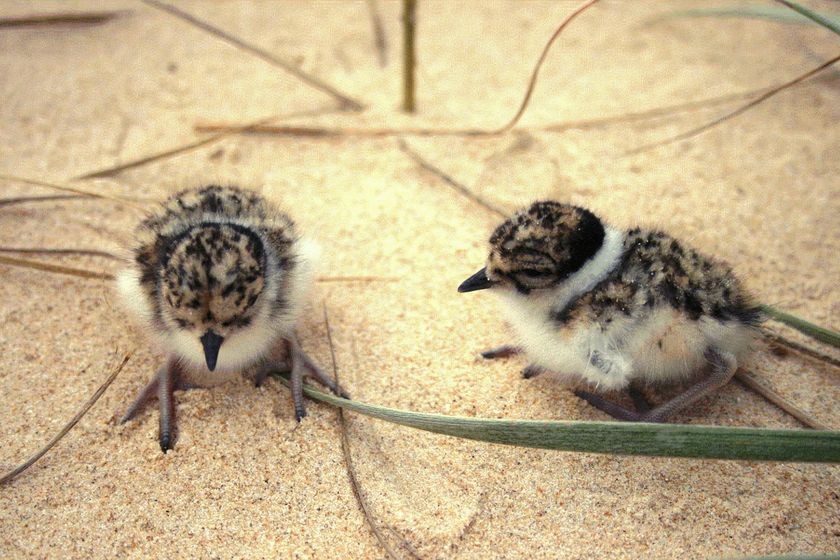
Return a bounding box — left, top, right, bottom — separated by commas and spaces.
117, 186, 346, 451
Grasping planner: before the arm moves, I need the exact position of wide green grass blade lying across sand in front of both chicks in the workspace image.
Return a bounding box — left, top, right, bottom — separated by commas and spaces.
272, 376, 840, 463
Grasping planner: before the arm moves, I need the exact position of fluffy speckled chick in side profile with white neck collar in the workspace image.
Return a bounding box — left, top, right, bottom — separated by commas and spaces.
458, 202, 761, 422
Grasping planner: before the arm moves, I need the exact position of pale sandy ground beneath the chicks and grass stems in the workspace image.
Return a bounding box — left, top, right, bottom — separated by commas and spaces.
0, 2, 840, 559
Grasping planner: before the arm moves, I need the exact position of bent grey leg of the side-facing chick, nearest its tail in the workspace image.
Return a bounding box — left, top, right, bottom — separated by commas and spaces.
575, 349, 738, 422
